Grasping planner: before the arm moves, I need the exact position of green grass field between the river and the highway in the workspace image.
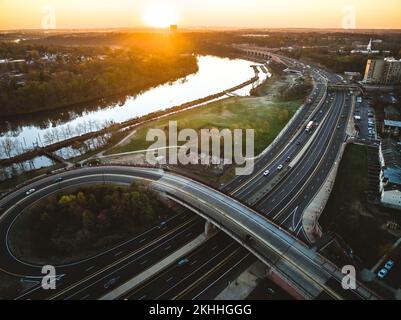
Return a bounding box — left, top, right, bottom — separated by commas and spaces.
109, 93, 303, 154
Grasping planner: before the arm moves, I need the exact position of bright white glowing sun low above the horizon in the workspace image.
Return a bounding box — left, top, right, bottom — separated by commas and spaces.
143, 1, 178, 28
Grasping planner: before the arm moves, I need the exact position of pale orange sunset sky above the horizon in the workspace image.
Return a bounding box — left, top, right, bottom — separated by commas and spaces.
0, 0, 401, 30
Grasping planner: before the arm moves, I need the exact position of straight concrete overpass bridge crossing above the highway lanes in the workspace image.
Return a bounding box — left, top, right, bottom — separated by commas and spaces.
149, 171, 380, 300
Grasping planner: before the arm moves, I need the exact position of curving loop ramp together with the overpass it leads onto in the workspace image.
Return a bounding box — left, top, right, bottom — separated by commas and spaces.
0, 167, 380, 299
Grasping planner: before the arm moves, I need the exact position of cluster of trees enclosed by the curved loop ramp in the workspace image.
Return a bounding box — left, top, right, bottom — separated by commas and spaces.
11, 183, 173, 258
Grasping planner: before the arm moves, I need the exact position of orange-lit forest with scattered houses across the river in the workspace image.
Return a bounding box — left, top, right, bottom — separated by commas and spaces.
0, 44, 198, 117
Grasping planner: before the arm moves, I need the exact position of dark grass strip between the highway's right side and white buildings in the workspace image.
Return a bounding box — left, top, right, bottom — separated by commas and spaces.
319, 144, 393, 266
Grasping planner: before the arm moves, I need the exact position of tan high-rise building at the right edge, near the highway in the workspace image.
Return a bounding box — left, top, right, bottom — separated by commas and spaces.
363, 58, 401, 86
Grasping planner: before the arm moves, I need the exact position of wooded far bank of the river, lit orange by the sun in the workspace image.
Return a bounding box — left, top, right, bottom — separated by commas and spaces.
0, 49, 199, 120
